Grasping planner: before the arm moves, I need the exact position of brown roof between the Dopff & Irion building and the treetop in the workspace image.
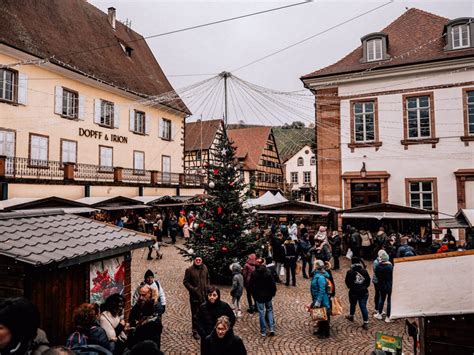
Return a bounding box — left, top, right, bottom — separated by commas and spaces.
184, 120, 222, 152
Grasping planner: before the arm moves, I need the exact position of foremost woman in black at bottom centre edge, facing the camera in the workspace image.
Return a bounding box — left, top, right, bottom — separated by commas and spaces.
201, 316, 247, 355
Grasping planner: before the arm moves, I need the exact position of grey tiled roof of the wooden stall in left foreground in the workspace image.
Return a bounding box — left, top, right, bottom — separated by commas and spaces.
0, 211, 153, 267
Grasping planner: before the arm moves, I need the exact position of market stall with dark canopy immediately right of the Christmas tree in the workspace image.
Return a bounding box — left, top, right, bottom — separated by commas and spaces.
256, 201, 337, 230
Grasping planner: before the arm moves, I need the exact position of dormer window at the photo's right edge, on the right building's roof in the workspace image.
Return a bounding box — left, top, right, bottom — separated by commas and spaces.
444, 17, 474, 51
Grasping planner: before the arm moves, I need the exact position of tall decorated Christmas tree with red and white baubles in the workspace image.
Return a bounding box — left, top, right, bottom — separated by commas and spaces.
181, 133, 264, 283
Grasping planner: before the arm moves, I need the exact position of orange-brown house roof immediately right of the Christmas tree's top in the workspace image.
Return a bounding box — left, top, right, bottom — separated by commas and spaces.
227, 127, 272, 170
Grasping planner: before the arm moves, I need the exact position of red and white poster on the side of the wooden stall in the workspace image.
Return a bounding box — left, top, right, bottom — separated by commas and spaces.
89, 256, 125, 304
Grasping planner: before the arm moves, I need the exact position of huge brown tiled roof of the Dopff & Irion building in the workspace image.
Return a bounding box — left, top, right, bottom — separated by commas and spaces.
0, 0, 189, 113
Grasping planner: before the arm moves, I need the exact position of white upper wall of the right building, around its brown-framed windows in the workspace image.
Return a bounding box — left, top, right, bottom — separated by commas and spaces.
339, 70, 474, 214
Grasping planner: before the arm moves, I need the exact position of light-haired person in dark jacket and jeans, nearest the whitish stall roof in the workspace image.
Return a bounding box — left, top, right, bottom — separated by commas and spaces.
374, 251, 393, 323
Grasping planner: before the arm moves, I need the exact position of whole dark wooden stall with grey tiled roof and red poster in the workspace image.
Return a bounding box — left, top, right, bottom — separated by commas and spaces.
0, 210, 153, 344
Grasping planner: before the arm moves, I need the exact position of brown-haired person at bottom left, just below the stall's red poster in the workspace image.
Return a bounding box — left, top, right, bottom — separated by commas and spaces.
66, 303, 112, 354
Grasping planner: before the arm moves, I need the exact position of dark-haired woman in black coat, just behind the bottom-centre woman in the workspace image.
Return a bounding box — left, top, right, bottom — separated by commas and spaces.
196, 286, 235, 349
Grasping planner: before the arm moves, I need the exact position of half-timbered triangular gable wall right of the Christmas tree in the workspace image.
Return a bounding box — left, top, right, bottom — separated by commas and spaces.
255, 133, 283, 195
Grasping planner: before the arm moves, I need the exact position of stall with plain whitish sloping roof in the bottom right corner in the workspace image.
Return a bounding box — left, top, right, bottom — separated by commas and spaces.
390, 250, 474, 355
